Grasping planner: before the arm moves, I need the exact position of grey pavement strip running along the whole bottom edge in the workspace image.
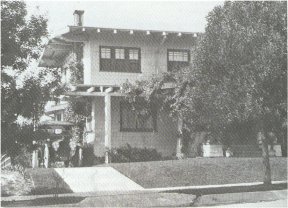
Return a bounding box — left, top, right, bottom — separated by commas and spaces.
2, 190, 287, 207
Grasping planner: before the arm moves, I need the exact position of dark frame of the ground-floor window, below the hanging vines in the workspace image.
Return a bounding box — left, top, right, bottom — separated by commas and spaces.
119, 101, 158, 132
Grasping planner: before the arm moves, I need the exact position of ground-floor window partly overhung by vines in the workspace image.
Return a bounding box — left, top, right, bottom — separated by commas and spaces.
120, 102, 157, 132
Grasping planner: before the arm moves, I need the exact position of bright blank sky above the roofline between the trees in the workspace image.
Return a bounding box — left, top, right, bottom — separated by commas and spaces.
26, 0, 223, 36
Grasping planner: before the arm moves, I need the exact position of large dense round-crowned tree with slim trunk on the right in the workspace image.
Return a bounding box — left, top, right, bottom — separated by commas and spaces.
177, 2, 287, 184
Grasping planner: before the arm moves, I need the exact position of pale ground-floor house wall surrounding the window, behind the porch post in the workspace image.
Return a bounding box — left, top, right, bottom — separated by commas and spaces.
93, 97, 177, 156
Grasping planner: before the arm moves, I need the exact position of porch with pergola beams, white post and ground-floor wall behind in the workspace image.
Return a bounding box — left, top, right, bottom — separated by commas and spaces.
66, 85, 180, 163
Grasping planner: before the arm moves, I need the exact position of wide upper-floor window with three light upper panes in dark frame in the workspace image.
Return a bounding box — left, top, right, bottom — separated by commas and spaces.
100, 46, 141, 73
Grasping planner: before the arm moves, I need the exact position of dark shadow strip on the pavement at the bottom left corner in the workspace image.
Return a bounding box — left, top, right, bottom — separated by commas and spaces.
1, 197, 85, 207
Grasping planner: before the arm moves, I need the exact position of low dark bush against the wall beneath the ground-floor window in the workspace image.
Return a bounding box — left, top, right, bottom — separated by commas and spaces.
109, 144, 163, 163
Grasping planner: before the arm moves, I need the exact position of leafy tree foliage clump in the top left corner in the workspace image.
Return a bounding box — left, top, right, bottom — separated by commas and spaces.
1, 1, 48, 70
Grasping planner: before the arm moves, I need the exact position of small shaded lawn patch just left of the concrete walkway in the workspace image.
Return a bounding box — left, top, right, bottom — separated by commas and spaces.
26, 168, 73, 195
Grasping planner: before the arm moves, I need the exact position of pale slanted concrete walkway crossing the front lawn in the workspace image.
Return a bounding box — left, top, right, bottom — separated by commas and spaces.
55, 167, 144, 193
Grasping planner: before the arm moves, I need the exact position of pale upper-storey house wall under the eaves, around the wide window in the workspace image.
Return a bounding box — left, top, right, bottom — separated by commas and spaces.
83, 33, 195, 85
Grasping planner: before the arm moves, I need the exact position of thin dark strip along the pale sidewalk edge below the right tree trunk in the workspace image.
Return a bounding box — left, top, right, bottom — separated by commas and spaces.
165, 183, 287, 196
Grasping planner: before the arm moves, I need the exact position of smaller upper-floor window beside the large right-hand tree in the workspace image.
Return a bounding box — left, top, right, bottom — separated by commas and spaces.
167, 49, 190, 71
